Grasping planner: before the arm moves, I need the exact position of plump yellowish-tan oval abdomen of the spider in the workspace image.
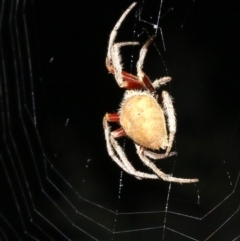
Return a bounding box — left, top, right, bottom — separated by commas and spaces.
119, 91, 168, 150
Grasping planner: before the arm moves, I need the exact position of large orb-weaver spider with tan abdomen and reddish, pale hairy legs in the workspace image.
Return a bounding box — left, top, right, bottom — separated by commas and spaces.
103, 2, 198, 183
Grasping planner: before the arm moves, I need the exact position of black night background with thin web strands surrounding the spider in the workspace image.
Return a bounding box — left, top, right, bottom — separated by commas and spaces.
0, 0, 240, 241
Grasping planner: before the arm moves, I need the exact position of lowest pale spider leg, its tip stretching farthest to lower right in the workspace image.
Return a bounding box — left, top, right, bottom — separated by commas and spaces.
135, 144, 199, 183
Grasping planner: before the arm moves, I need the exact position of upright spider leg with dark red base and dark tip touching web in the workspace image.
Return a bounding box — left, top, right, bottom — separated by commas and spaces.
137, 36, 156, 93
